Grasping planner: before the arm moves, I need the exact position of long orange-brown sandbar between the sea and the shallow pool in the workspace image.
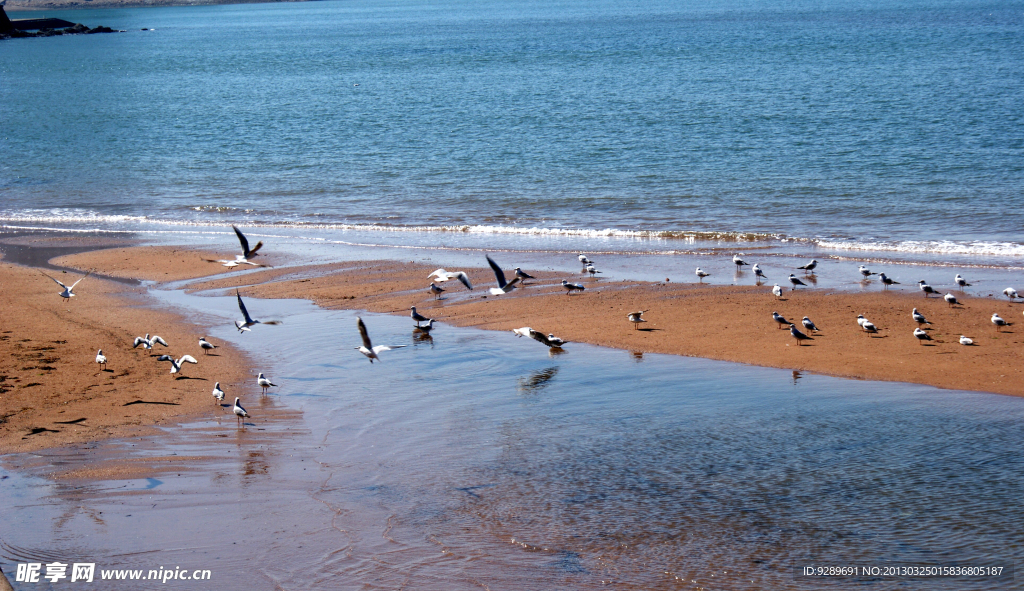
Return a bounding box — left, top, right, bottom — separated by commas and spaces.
61, 243, 1024, 395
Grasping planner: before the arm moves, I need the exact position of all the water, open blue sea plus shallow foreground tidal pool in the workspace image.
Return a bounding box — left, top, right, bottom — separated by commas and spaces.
0, 0, 1024, 591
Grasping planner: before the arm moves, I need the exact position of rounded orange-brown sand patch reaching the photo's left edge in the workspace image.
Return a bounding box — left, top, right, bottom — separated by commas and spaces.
0, 241, 258, 454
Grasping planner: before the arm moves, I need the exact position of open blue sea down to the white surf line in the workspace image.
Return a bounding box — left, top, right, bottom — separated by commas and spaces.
0, 0, 1024, 258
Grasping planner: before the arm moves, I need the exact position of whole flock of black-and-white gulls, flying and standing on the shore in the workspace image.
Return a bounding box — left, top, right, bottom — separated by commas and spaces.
43, 225, 1020, 427
